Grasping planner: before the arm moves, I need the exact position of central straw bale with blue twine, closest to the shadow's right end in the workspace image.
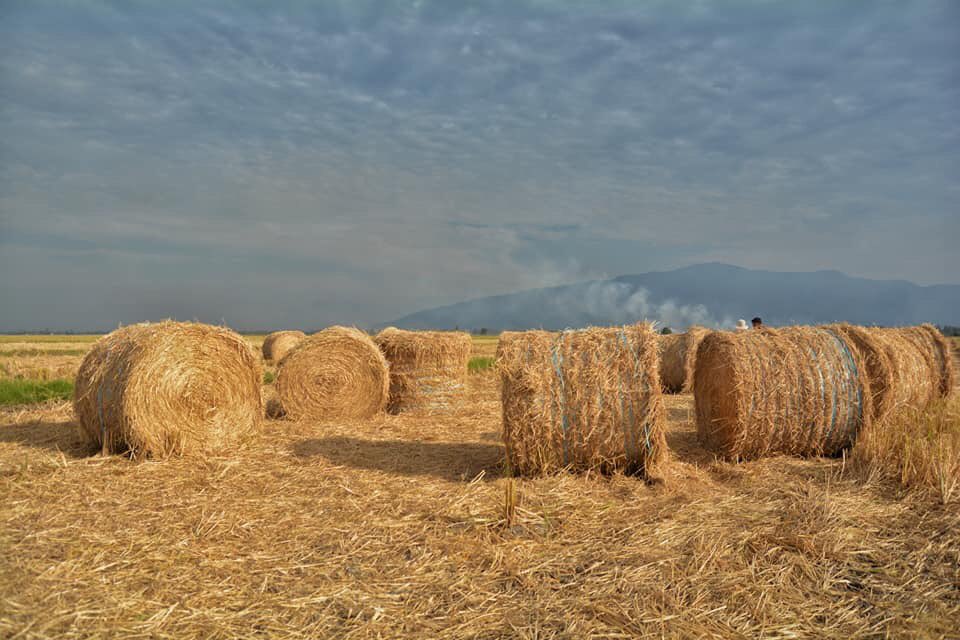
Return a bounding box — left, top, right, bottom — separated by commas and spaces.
497, 325, 666, 478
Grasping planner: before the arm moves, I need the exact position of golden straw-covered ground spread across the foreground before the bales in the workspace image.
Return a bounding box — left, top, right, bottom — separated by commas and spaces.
0, 332, 960, 638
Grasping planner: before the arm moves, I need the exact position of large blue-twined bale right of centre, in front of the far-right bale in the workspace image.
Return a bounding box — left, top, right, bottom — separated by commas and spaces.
693, 327, 873, 459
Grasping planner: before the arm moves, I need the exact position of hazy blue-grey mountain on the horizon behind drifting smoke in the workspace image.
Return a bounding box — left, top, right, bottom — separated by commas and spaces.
388, 263, 960, 332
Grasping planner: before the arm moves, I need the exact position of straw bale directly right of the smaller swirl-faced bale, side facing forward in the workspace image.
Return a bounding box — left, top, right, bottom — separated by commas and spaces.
374, 327, 473, 413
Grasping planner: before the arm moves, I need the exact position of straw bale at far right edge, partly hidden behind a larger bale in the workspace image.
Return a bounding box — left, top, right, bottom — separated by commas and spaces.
831, 324, 953, 419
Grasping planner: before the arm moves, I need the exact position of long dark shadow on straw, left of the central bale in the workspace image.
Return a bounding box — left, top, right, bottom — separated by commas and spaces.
293, 437, 503, 482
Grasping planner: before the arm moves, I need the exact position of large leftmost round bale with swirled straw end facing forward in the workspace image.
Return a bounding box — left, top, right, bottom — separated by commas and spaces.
73, 321, 263, 458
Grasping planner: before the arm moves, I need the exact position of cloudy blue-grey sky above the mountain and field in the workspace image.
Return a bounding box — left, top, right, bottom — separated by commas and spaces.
0, 0, 960, 331
